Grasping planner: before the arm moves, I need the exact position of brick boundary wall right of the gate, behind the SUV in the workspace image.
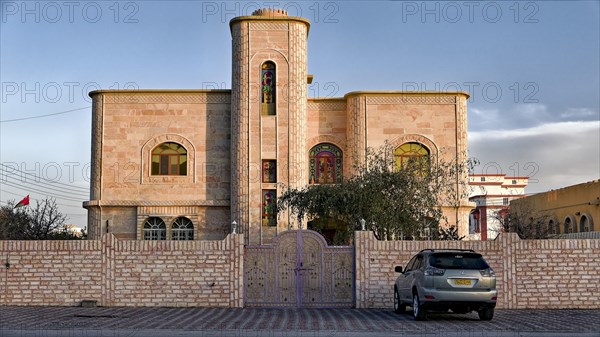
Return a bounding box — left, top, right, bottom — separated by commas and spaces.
355, 232, 600, 309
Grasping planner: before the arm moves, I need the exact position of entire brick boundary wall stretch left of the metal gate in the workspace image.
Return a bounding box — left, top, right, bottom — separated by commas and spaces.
0, 234, 244, 307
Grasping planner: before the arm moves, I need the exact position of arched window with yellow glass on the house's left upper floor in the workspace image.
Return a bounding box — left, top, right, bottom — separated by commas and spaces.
152, 142, 187, 176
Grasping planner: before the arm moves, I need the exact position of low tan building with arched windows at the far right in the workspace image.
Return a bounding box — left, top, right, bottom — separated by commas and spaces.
510, 180, 600, 234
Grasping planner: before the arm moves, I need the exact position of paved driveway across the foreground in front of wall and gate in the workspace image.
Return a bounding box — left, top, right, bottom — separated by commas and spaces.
0, 307, 600, 337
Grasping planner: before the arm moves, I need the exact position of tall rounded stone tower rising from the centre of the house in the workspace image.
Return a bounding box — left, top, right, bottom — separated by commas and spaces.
229, 9, 310, 244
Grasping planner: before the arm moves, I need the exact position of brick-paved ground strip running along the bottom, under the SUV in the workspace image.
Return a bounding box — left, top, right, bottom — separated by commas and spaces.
0, 306, 600, 336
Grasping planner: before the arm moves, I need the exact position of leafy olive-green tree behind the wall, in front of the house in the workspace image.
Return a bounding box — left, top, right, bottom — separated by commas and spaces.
277, 143, 469, 240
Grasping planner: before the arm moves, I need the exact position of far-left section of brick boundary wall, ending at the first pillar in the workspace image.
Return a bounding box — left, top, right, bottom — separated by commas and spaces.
0, 241, 103, 305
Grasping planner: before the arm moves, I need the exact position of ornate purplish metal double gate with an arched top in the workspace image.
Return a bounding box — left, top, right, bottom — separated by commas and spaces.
244, 230, 354, 308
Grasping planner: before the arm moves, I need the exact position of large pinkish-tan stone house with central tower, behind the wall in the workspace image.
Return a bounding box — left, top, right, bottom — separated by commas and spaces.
84, 10, 471, 244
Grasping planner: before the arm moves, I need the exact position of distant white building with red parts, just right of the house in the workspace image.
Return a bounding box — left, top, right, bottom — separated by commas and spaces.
469, 174, 529, 240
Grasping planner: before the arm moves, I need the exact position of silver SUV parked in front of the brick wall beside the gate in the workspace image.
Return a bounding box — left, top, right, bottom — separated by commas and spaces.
394, 249, 498, 320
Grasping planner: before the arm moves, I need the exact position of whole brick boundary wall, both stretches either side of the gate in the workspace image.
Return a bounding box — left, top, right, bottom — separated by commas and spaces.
0, 232, 600, 309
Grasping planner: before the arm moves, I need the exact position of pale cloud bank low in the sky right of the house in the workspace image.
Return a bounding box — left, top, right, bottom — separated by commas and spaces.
469, 121, 600, 193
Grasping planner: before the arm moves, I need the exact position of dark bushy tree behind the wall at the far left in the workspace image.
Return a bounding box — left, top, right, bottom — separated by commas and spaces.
0, 198, 81, 240
